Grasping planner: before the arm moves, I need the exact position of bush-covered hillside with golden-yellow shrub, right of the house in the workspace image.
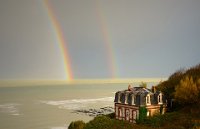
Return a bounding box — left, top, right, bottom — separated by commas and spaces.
156, 64, 200, 111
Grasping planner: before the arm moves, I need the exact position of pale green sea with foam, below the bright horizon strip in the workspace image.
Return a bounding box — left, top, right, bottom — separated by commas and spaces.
0, 83, 158, 129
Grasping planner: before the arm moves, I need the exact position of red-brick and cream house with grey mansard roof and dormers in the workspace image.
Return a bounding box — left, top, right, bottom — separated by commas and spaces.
114, 86, 166, 123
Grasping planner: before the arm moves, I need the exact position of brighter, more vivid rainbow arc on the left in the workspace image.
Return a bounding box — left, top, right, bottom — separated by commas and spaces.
44, 0, 73, 81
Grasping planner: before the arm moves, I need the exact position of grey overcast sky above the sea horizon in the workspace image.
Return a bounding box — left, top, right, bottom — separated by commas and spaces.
0, 0, 200, 80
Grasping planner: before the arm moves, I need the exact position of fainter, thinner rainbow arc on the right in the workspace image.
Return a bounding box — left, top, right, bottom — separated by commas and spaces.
97, 1, 117, 78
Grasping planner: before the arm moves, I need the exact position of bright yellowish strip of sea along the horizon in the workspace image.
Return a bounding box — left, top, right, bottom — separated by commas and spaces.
0, 77, 167, 87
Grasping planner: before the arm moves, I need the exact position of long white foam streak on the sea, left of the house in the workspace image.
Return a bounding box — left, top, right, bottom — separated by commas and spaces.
40, 97, 114, 109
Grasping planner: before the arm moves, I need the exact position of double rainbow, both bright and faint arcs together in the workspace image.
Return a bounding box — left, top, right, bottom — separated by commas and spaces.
44, 0, 117, 81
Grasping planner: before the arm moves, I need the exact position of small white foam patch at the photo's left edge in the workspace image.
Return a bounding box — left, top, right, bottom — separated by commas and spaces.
0, 103, 20, 116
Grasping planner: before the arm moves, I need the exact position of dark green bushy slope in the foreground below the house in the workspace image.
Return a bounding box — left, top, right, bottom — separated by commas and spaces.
68, 106, 200, 129
